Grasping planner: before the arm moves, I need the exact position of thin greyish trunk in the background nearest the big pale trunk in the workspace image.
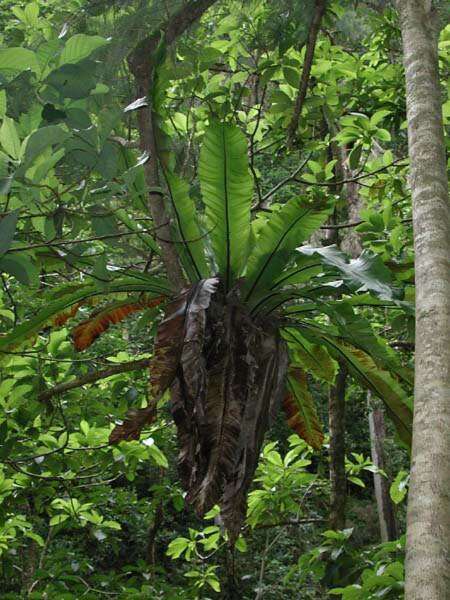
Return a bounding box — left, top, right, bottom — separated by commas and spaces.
367, 392, 397, 542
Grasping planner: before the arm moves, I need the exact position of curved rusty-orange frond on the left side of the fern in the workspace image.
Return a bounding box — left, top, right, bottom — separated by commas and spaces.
72, 296, 165, 351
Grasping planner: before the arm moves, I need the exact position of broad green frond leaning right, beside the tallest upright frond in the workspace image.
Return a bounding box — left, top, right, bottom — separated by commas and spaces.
243, 198, 332, 300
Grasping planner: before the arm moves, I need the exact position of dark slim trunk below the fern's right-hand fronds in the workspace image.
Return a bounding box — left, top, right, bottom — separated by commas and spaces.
328, 364, 347, 529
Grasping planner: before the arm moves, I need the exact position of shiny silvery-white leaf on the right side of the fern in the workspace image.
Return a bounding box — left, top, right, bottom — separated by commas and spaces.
297, 246, 401, 300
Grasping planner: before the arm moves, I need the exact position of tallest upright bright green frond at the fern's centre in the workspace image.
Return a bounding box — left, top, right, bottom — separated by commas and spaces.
199, 121, 253, 289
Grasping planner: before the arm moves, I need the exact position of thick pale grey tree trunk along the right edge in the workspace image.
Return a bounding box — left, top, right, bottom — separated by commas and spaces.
397, 0, 450, 600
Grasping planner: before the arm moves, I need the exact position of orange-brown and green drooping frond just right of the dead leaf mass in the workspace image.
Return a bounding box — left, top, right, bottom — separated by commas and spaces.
283, 369, 324, 450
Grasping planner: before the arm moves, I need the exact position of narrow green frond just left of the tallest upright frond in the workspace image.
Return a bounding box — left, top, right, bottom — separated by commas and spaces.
165, 172, 210, 281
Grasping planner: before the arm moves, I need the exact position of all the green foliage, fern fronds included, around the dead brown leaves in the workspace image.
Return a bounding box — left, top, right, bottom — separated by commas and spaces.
0, 0, 442, 600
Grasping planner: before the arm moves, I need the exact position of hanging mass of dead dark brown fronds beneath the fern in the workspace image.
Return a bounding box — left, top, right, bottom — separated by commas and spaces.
171, 284, 288, 540
